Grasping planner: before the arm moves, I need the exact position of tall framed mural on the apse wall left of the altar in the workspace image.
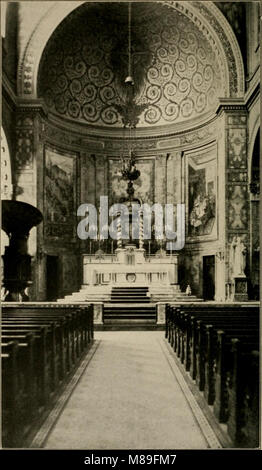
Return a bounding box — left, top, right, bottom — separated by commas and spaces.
44, 146, 77, 241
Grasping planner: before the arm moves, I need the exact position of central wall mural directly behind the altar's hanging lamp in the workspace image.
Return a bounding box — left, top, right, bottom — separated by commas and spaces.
108, 157, 155, 204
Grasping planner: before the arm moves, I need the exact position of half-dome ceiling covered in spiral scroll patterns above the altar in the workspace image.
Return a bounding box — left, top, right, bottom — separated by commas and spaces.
38, 3, 223, 127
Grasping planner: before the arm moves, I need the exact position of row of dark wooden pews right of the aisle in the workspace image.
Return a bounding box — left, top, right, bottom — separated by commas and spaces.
165, 304, 259, 448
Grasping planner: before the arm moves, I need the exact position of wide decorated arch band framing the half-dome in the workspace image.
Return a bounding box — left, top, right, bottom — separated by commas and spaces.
17, 0, 244, 98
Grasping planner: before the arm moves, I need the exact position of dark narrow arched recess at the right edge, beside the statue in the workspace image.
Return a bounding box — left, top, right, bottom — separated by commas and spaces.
250, 129, 261, 300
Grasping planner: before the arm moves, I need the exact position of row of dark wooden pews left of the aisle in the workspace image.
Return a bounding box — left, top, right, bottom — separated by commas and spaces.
1, 303, 94, 448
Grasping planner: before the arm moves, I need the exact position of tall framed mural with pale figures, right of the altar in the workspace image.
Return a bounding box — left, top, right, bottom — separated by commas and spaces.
185, 145, 217, 241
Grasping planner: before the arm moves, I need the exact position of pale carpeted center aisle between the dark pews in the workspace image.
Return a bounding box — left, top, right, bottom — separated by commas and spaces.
44, 331, 219, 450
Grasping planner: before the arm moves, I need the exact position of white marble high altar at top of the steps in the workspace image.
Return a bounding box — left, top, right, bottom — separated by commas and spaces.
77, 244, 180, 301
